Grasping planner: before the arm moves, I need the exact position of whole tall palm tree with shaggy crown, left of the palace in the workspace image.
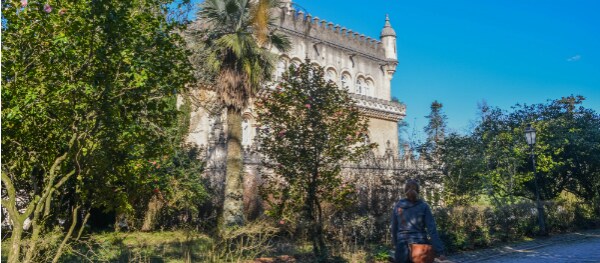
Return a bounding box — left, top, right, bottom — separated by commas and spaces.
191, 0, 290, 226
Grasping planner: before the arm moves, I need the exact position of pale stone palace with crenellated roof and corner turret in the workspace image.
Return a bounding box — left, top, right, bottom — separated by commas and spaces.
188, 1, 436, 220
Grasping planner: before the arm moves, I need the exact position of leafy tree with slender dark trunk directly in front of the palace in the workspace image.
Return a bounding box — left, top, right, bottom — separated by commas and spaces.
256, 60, 375, 261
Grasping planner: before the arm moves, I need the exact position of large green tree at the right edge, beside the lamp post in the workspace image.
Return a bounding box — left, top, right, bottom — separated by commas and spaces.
509, 96, 600, 215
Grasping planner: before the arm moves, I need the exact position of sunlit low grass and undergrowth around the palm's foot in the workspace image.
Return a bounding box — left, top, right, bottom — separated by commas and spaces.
56, 225, 277, 262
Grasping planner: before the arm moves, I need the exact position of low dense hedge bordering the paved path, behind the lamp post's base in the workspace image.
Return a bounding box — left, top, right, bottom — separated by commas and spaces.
434, 200, 599, 254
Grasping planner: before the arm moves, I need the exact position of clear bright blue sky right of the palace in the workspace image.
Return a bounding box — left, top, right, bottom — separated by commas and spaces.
191, 0, 600, 140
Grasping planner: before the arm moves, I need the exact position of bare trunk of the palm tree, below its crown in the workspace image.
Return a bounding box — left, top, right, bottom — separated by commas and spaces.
222, 109, 244, 227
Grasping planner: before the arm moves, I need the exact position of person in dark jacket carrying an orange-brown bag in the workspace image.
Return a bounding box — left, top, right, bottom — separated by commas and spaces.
392, 179, 446, 263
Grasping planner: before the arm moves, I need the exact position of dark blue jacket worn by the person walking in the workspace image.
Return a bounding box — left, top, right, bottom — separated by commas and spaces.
392, 199, 444, 255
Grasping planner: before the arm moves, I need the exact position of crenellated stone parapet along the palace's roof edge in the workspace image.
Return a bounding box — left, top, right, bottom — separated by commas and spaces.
278, 6, 392, 65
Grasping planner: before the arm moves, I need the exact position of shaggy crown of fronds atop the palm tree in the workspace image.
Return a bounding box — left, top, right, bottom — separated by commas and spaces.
188, 0, 290, 111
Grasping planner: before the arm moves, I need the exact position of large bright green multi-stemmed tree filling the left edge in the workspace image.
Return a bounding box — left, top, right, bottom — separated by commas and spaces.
2, 0, 191, 262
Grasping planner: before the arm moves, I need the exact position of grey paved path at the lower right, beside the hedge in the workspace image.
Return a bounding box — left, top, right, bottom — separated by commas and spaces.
449, 230, 600, 263
